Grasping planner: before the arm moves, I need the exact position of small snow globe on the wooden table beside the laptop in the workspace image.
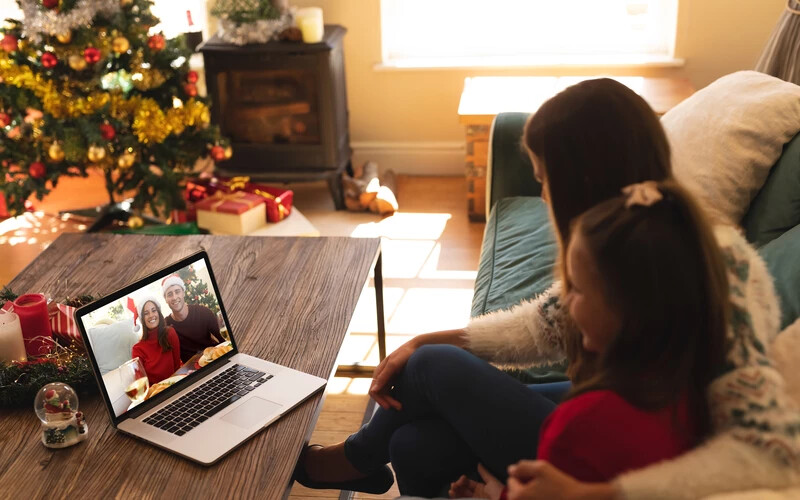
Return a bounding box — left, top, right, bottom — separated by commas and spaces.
33, 382, 89, 448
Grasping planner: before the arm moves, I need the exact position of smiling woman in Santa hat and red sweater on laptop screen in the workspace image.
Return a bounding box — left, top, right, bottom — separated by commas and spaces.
131, 297, 181, 385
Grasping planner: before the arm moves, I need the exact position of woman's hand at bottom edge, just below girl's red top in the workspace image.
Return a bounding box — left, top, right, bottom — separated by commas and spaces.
508, 460, 617, 500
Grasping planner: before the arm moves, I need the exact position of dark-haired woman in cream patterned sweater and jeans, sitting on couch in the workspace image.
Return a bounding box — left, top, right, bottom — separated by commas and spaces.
301, 79, 800, 499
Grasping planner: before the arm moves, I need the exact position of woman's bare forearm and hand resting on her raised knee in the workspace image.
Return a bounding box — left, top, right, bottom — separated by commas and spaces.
369, 330, 466, 411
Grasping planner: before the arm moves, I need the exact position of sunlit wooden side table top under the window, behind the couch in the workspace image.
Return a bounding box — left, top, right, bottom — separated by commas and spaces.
458, 76, 694, 125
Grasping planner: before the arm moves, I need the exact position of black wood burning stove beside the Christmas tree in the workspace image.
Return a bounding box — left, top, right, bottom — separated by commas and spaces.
199, 25, 351, 209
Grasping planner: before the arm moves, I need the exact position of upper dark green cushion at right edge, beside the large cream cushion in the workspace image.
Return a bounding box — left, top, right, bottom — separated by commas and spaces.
742, 134, 800, 247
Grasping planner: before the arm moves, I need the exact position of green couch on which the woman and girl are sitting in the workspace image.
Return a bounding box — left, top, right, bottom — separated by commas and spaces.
471, 102, 800, 499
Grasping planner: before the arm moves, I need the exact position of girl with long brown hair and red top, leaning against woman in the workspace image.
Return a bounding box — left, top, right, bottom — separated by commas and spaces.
450, 181, 728, 496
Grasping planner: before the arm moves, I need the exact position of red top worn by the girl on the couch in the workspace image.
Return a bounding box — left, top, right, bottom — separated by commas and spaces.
537, 390, 692, 482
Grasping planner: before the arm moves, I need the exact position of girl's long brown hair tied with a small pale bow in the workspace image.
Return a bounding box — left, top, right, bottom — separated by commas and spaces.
565, 180, 729, 438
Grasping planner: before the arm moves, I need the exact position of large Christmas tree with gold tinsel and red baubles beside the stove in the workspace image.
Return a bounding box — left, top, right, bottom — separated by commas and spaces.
0, 0, 231, 216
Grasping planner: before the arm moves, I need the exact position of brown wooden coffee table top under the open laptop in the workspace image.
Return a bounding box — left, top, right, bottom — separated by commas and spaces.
0, 234, 380, 498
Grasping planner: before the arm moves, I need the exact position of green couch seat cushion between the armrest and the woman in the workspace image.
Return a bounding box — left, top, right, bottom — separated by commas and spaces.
472, 196, 567, 383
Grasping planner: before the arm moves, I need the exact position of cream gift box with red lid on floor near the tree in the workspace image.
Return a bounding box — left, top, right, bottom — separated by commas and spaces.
195, 191, 267, 234
